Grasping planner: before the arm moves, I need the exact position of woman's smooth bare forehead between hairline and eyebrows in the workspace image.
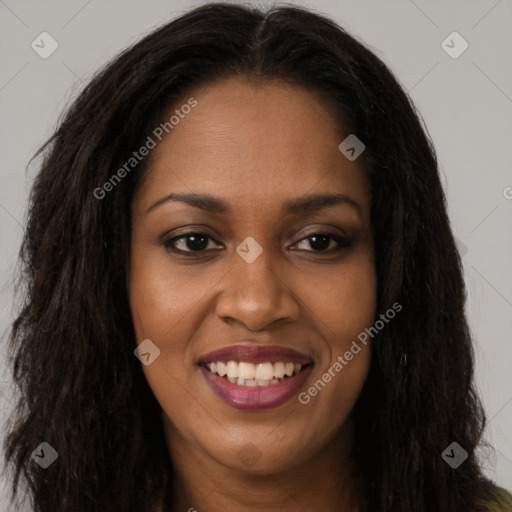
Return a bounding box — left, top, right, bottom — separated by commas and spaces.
135, 78, 368, 210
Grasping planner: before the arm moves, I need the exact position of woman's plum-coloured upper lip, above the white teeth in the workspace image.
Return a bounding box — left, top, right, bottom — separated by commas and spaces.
199, 345, 313, 365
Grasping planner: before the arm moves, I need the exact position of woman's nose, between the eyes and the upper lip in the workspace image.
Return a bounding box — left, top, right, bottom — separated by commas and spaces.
216, 250, 300, 331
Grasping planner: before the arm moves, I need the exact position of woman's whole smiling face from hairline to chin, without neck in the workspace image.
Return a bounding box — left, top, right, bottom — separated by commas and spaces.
129, 78, 376, 473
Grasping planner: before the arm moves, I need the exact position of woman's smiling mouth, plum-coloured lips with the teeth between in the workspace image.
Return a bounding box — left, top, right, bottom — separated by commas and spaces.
198, 345, 314, 411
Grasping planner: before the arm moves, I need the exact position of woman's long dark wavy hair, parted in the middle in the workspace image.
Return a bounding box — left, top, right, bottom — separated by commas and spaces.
4, 3, 504, 512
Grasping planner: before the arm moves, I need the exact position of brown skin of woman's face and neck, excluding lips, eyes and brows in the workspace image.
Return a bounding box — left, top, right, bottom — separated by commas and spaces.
129, 78, 376, 512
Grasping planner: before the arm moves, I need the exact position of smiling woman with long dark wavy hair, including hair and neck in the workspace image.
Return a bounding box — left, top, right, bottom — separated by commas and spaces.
2, 4, 511, 512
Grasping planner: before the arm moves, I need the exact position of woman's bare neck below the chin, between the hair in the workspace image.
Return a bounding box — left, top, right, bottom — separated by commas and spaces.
165, 419, 359, 512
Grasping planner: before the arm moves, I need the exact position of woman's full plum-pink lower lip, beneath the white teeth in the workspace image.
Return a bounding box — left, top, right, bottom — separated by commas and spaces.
200, 365, 312, 411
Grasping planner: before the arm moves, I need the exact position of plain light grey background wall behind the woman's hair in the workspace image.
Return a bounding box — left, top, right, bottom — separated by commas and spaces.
0, 0, 512, 510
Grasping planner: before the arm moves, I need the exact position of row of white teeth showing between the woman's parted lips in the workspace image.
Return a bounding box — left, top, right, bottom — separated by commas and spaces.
206, 361, 308, 387
